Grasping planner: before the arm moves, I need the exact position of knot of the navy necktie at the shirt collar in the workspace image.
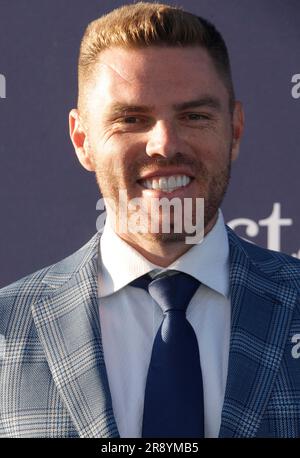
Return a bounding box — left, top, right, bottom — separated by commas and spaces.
132, 272, 200, 313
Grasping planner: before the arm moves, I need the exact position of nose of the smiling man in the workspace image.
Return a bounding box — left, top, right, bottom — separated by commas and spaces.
146, 120, 183, 159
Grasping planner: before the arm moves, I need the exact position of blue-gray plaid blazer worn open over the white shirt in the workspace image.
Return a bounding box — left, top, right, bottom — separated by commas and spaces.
0, 228, 300, 438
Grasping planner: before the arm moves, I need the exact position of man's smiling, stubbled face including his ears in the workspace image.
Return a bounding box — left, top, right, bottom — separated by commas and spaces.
70, 46, 243, 262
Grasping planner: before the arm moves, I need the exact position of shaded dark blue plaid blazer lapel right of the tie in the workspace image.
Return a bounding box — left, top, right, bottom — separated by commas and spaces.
219, 230, 297, 437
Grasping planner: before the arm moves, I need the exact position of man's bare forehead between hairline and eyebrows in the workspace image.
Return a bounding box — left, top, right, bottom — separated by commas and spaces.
88, 46, 228, 107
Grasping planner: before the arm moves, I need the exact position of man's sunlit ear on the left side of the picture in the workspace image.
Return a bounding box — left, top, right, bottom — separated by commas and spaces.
69, 108, 95, 172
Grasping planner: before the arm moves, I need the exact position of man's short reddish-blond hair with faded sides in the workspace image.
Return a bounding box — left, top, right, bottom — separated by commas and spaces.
78, 2, 235, 112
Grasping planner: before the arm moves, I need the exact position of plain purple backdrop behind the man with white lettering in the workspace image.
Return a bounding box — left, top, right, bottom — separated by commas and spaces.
0, 0, 300, 287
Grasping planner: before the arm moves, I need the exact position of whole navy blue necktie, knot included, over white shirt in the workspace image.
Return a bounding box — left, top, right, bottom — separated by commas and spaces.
131, 272, 204, 438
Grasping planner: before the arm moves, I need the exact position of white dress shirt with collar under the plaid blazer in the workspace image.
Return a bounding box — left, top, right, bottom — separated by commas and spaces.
98, 211, 231, 437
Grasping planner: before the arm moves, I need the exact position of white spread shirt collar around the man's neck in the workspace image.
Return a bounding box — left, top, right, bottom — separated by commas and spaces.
99, 210, 229, 297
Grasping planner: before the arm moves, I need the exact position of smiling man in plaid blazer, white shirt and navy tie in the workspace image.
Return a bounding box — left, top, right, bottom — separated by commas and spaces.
0, 3, 300, 437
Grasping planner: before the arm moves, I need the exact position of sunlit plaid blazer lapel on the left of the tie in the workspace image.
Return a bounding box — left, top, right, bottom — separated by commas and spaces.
32, 234, 118, 437
